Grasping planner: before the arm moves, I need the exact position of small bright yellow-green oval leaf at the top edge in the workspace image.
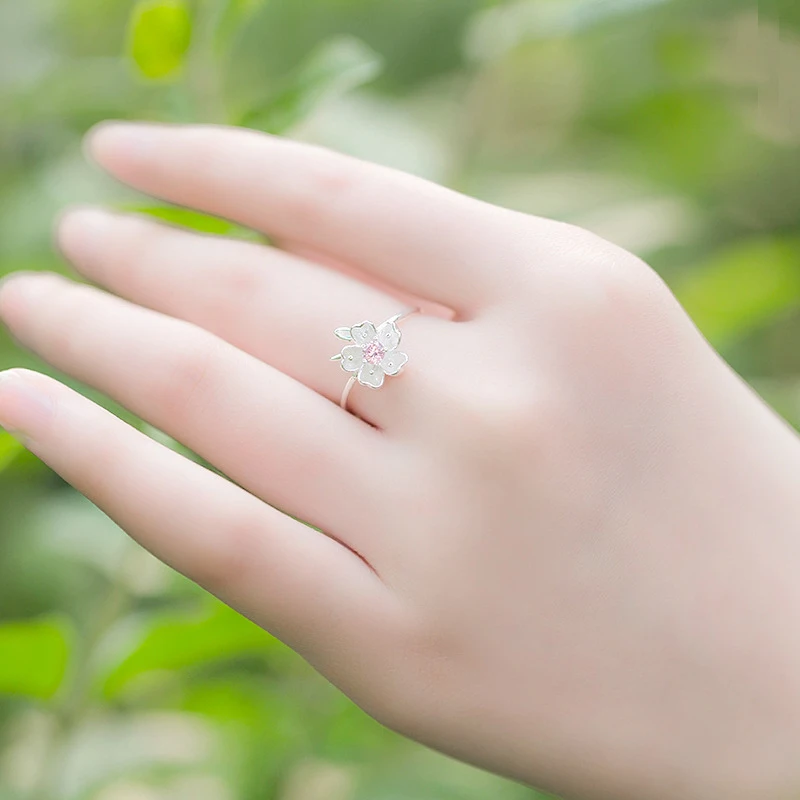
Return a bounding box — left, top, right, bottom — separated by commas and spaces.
128, 0, 192, 80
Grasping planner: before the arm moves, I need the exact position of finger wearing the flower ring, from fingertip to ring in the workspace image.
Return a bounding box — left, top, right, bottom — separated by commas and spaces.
58, 209, 438, 416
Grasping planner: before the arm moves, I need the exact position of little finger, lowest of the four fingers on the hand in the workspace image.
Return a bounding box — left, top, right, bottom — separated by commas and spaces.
0, 370, 390, 652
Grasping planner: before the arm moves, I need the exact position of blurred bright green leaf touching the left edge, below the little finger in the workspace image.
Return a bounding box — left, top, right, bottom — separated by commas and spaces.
0, 619, 71, 699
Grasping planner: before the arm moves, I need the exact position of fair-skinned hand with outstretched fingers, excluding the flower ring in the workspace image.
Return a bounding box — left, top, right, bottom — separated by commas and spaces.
0, 124, 800, 800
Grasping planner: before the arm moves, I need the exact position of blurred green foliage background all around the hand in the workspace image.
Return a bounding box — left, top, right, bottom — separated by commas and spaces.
0, 0, 800, 800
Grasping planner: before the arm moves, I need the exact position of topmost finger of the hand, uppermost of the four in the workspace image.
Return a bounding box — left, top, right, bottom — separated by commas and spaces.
88, 123, 511, 315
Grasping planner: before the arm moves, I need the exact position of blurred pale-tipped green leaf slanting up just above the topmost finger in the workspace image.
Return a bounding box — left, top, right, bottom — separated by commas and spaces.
242, 36, 383, 133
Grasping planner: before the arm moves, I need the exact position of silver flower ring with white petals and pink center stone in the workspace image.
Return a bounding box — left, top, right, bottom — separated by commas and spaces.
331, 308, 420, 410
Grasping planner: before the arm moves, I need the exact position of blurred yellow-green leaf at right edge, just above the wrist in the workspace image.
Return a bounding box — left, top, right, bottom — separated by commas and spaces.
674, 239, 800, 345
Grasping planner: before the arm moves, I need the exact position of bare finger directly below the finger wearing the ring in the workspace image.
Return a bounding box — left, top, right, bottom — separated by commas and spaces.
0, 275, 385, 551
